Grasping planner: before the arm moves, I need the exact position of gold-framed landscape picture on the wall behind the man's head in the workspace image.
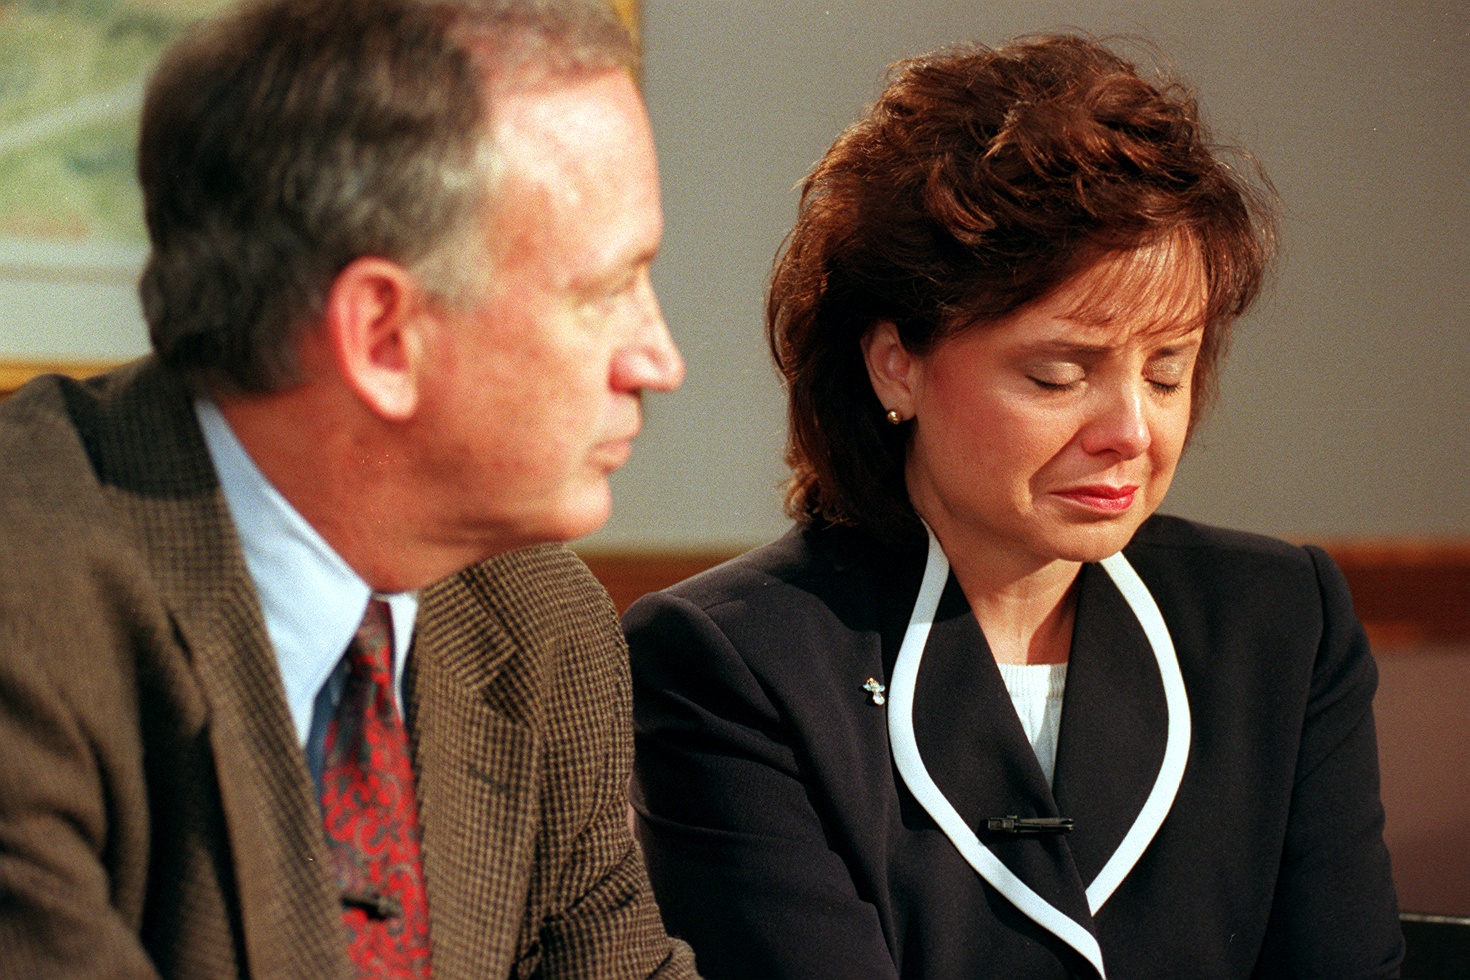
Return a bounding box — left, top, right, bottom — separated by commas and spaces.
0, 0, 228, 394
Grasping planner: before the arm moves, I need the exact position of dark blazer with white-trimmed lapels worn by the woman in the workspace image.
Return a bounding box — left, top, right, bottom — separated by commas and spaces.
625, 517, 1402, 980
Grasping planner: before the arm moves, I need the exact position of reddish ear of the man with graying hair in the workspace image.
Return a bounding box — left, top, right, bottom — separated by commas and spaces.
322, 257, 431, 422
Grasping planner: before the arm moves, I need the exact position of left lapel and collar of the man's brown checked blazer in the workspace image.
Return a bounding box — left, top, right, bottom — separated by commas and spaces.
98, 361, 348, 977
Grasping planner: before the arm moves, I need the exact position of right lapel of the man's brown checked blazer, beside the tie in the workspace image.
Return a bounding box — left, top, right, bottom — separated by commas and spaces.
404, 554, 544, 977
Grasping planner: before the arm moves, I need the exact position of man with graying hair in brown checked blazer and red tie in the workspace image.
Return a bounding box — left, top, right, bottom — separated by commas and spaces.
0, 0, 694, 980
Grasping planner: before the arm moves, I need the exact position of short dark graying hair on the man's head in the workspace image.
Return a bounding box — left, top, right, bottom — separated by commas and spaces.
138, 0, 637, 392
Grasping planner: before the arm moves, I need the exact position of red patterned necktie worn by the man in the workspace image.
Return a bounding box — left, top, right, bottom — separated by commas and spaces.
322, 599, 429, 979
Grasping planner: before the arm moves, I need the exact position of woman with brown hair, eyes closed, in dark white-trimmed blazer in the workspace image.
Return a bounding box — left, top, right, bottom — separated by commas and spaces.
625, 35, 1402, 980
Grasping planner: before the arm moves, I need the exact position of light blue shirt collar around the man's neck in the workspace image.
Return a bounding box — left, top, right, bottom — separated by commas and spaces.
194, 398, 419, 745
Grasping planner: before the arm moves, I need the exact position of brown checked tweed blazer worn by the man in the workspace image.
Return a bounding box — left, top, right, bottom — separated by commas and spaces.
0, 360, 694, 980
